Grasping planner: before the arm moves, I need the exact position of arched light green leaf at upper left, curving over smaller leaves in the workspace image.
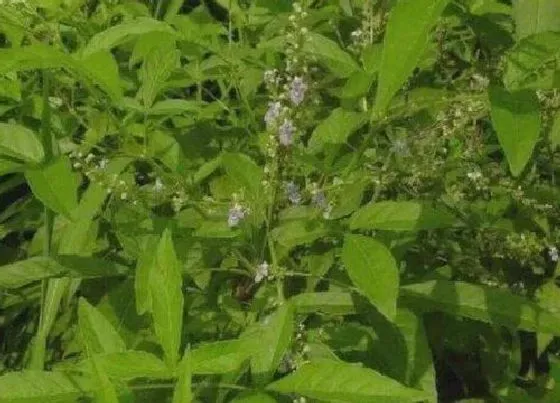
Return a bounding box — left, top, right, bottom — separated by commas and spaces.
81, 18, 175, 56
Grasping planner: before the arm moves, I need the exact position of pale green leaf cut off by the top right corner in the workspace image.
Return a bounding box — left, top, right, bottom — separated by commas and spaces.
513, 0, 560, 39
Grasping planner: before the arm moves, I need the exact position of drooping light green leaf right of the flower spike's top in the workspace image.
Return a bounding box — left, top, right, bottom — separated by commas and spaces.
303, 32, 360, 77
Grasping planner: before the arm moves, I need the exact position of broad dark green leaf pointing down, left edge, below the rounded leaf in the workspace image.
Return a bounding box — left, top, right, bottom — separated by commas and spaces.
25, 157, 78, 218
